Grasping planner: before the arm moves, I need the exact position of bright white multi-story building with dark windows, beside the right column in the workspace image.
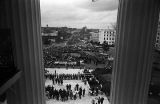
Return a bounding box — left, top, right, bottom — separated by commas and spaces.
99, 29, 116, 45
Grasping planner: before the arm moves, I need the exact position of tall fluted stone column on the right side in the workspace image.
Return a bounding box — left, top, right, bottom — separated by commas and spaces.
111, 0, 160, 104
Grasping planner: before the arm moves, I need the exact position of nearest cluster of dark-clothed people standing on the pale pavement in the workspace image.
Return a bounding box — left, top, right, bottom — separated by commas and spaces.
45, 84, 86, 102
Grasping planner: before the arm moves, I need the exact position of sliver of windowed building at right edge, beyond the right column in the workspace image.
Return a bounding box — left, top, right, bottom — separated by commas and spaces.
155, 14, 160, 50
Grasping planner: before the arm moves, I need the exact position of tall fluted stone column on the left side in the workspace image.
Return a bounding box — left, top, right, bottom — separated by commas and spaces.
7, 0, 45, 104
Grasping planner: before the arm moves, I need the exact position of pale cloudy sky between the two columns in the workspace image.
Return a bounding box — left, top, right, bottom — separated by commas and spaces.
40, 0, 118, 29
